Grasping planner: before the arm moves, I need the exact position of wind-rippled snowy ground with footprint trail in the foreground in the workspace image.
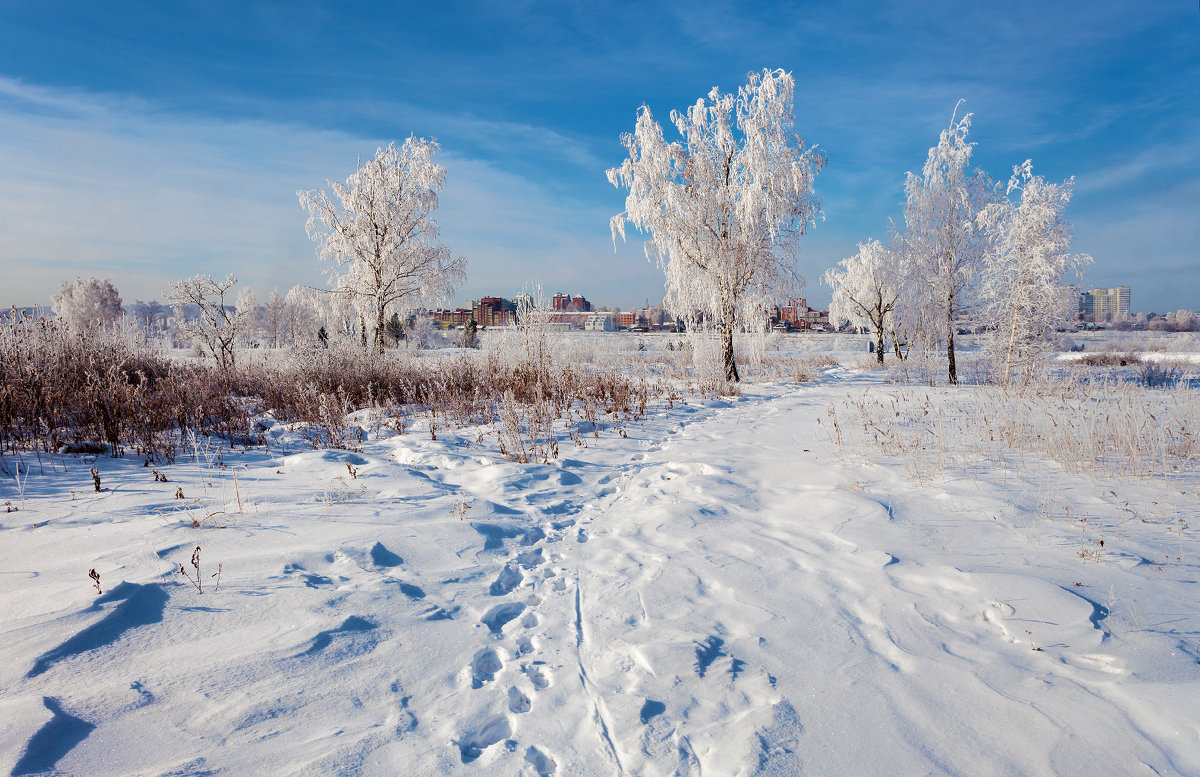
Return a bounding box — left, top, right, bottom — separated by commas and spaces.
0, 368, 1200, 776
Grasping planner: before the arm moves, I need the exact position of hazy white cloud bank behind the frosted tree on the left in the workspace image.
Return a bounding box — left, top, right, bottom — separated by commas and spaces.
0, 78, 661, 307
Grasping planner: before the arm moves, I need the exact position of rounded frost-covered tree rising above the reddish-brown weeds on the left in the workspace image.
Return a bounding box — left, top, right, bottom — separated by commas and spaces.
296, 138, 467, 351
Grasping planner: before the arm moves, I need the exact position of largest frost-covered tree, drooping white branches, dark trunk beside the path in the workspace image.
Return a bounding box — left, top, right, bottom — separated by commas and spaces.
608, 70, 826, 380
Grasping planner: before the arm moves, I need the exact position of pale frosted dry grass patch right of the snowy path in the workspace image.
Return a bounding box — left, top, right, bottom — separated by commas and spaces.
822, 381, 1200, 482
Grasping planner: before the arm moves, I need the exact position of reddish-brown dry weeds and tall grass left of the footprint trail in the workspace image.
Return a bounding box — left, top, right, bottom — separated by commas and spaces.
0, 306, 659, 460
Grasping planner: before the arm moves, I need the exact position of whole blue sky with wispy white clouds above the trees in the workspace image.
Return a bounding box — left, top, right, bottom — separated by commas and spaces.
0, 0, 1200, 311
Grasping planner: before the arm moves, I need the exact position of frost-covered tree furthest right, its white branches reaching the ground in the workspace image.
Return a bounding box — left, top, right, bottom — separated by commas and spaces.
979, 159, 1092, 387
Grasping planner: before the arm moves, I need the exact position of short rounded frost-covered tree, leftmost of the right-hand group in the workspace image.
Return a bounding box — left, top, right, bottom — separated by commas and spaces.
823, 240, 904, 365
